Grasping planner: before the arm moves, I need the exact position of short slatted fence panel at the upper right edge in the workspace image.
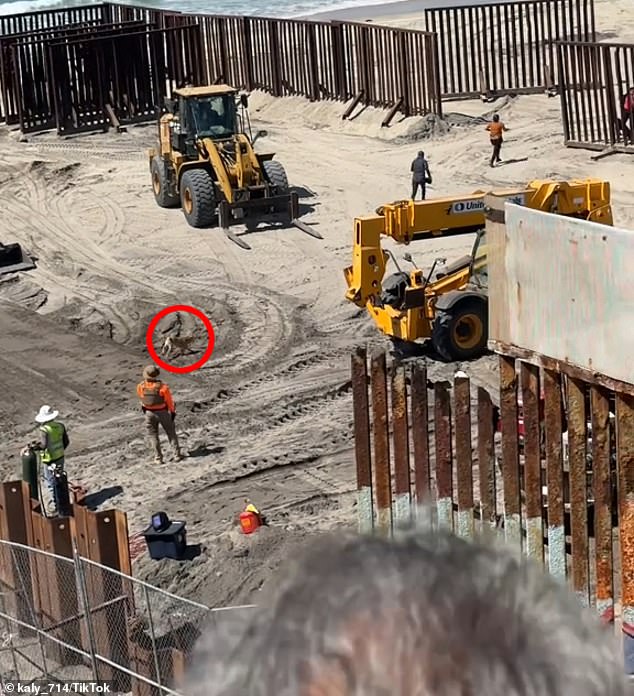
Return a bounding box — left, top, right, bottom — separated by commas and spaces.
555, 42, 634, 153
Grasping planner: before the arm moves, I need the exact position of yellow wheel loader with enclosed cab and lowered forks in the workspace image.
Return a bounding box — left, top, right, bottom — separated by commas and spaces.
148, 85, 322, 249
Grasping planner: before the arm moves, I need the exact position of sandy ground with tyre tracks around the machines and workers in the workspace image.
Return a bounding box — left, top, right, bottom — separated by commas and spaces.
0, 0, 634, 606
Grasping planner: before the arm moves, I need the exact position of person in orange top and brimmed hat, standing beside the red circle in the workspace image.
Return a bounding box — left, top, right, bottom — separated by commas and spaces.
136, 365, 183, 464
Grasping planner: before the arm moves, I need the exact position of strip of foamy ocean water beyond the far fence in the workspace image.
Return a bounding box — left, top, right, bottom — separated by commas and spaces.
0, 0, 404, 17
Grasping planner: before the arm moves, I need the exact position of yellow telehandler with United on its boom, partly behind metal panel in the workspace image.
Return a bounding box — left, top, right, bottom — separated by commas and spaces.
344, 179, 612, 361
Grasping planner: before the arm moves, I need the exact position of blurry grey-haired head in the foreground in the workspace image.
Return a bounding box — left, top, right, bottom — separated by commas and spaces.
186, 529, 625, 696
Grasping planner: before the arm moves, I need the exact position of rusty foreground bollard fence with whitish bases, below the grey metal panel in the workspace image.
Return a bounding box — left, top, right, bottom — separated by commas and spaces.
352, 348, 634, 674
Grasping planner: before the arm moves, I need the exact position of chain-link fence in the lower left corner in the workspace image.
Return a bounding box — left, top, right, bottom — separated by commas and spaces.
0, 541, 254, 696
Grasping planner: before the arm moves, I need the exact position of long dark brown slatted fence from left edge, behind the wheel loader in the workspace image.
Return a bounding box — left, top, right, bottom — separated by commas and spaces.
0, 3, 442, 135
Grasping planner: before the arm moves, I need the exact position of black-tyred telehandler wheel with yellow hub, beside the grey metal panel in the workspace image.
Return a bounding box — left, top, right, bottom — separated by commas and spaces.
431, 297, 489, 362
